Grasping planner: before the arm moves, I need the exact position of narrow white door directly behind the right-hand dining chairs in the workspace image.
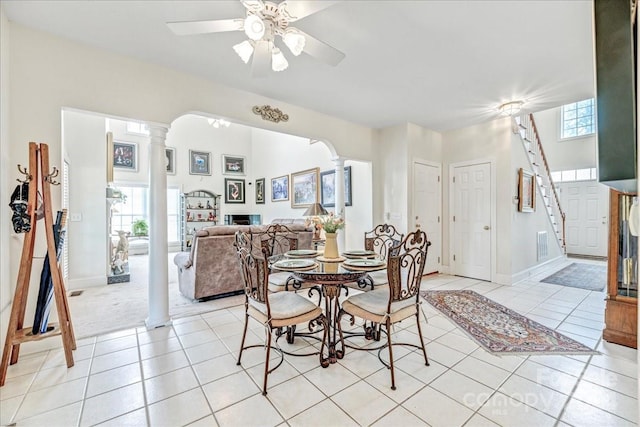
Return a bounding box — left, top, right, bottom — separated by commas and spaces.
413, 162, 442, 274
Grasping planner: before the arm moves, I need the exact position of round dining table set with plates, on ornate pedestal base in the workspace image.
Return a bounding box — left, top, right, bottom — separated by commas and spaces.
271, 251, 386, 368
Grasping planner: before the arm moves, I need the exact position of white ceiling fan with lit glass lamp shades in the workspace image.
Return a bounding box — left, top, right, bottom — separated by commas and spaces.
167, 0, 345, 76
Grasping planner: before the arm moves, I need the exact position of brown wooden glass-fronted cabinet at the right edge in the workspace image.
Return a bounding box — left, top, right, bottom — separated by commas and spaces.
602, 190, 638, 348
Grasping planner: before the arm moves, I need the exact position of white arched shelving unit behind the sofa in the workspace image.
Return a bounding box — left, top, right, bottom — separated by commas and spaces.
180, 190, 220, 251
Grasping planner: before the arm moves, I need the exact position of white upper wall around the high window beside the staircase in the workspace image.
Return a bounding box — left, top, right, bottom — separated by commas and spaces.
533, 107, 596, 171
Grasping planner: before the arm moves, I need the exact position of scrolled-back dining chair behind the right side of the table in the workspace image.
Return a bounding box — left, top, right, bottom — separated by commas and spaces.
346, 224, 404, 291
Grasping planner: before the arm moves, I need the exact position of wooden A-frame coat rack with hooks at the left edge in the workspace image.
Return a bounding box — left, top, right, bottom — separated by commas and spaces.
0, 142, 76, 386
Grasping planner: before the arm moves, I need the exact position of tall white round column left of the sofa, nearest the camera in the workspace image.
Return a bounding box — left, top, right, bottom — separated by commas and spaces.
145, 124, 171, 329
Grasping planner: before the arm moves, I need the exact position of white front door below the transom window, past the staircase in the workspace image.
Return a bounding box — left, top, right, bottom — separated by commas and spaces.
558, 181, 609, 257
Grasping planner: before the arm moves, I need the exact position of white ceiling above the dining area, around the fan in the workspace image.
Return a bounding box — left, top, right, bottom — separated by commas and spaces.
1, 0, 594, 131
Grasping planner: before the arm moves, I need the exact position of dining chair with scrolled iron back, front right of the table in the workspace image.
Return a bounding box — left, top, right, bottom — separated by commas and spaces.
338, 229, 431, 390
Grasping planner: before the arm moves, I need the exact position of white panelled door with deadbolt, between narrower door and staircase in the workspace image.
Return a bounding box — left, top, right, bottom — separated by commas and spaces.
451, 163, 492, 280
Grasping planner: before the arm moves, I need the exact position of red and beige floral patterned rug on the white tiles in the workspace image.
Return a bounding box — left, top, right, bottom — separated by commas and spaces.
420, 290, 599, 354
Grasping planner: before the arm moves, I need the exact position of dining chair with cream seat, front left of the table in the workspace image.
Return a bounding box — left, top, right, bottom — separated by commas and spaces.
234, 231, 328, 395
